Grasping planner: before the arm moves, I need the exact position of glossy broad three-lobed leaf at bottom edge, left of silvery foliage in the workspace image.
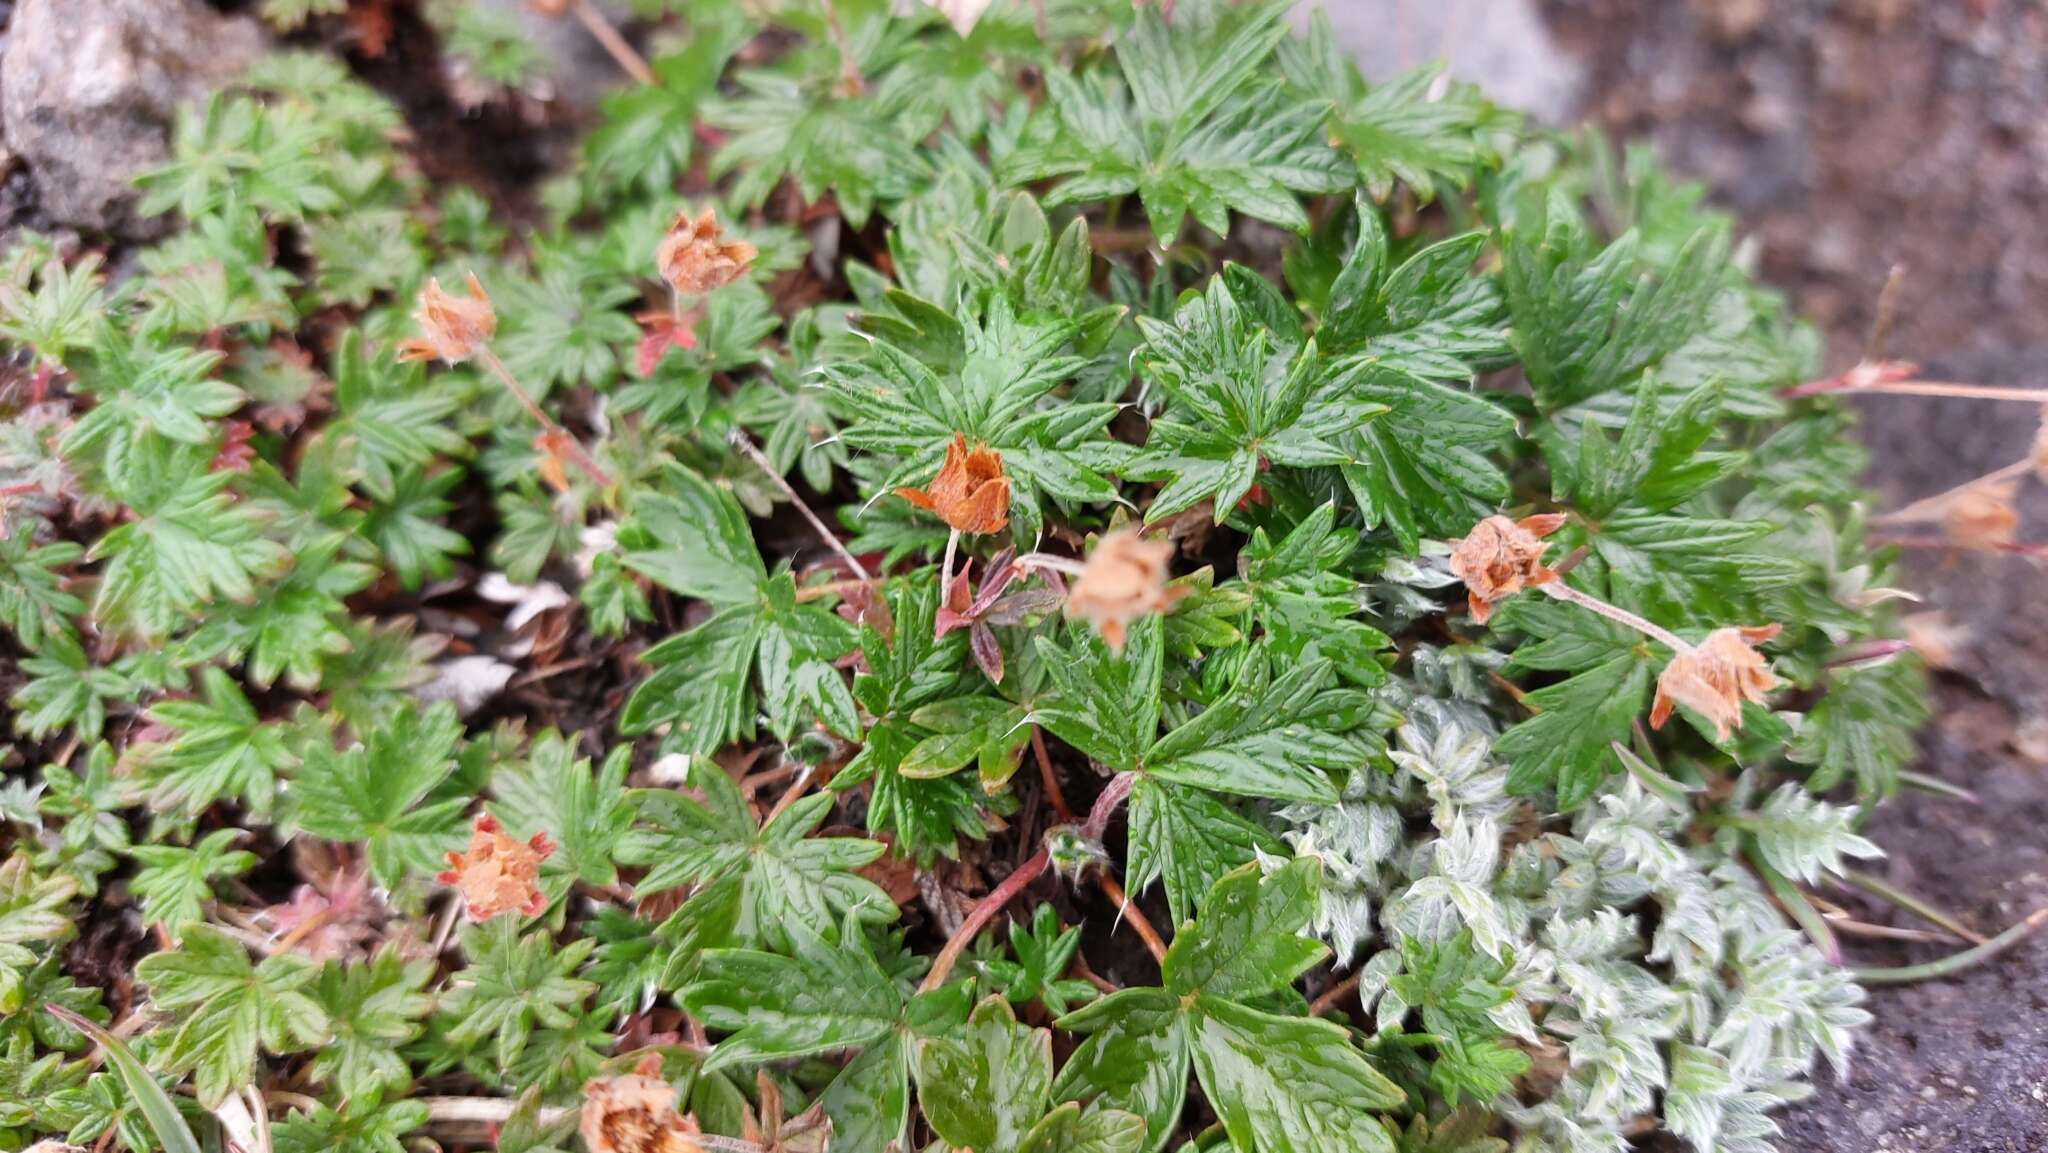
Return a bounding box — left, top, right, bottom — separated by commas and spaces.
1055, 860, 1405, 1153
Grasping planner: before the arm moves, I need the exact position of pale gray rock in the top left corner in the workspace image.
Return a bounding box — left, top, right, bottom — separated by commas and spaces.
0, 0, 266, 238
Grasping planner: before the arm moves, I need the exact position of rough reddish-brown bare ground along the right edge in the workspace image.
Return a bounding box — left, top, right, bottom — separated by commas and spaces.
1546, 0, 2048, 1153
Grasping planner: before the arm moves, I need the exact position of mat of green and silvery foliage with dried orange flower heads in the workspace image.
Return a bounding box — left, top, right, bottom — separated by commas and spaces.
0, 0, 2042, 1153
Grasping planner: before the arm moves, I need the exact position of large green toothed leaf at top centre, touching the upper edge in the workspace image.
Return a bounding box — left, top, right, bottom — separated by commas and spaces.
1001, 0, 1352, 246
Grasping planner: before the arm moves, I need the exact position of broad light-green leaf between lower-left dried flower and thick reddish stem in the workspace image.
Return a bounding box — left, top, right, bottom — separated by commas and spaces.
621, 758, 895, 948
